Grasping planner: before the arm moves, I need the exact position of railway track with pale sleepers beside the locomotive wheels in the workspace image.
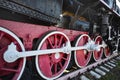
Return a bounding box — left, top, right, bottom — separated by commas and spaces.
56, 53, 120, 80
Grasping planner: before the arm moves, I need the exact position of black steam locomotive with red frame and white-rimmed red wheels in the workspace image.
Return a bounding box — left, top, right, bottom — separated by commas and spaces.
0, 0, 120, 80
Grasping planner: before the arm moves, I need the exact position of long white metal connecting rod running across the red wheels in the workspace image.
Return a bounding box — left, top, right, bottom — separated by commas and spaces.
3, 40, 106, 63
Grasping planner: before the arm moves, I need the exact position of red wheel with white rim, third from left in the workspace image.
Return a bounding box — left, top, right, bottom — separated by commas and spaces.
74, 34, 92, 68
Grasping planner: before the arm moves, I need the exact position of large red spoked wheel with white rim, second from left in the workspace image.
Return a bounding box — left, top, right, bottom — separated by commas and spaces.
35, 31, 71, 79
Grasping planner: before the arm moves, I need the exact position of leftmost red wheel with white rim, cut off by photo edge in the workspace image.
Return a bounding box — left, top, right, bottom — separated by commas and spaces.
0, 27, 26, 80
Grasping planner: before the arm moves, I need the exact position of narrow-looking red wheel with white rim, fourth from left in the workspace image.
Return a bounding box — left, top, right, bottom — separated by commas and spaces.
93, 36, 103, 61
